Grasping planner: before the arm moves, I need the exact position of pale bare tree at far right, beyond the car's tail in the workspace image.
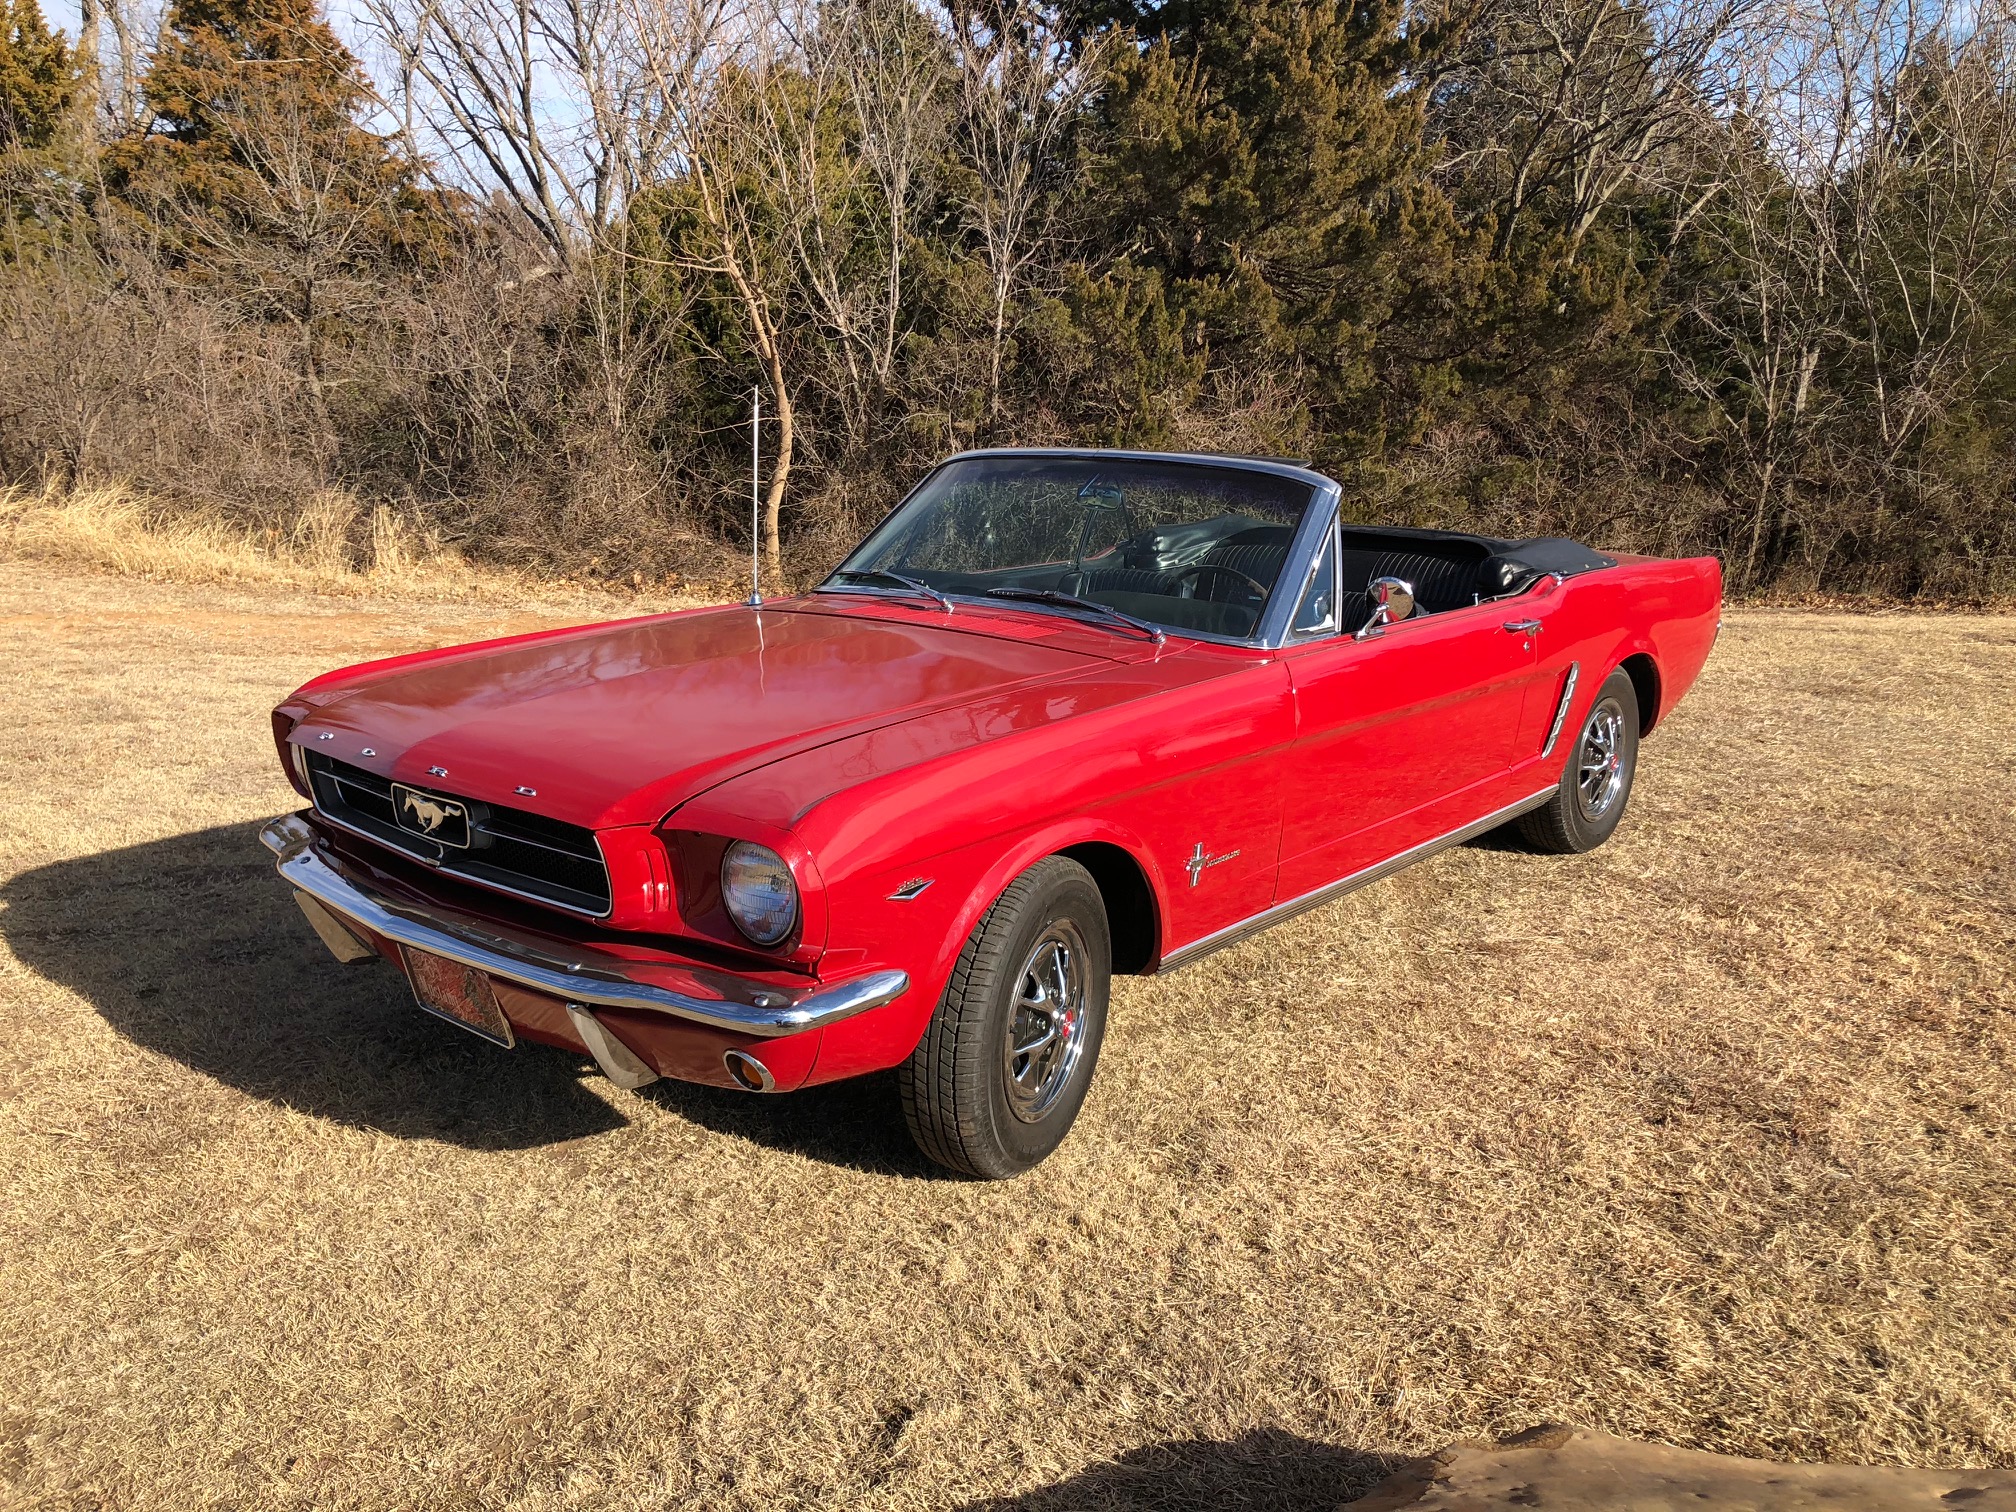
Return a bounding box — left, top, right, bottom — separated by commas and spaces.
1667, 0, 2016, 587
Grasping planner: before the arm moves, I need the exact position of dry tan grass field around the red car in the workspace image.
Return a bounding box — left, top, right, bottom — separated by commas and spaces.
0, 562, 2016, 1512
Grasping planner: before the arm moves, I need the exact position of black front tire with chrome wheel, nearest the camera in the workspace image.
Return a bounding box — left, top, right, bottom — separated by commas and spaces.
897, 857, 1113, 1181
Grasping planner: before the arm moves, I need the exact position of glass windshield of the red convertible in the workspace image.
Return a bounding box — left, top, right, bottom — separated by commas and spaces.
829, 456, 1312, 639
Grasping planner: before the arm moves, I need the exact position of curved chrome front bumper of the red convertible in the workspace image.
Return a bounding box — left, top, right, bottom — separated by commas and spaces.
260, 814, 909, 1038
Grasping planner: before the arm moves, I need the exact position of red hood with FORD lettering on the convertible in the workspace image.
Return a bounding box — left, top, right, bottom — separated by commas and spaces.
290, 607, 1105, 829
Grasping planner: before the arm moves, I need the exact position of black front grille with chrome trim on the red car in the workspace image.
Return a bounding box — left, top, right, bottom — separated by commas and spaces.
308, 750, 609, 915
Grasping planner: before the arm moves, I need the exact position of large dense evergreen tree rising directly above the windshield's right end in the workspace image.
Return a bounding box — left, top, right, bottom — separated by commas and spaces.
1064, 0, 1480, 464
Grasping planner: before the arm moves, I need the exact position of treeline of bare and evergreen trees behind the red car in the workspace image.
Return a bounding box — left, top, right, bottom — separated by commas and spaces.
0, 0, 2016, 599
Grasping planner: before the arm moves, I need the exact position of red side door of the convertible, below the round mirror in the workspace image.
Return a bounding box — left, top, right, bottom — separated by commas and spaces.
1274, 568, 1540, 901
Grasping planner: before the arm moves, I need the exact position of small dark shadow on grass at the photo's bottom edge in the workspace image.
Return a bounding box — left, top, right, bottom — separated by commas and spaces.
960, 1427, 1407, 1512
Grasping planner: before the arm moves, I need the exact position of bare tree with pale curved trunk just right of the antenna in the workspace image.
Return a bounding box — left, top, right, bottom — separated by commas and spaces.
633, 0, 950, 571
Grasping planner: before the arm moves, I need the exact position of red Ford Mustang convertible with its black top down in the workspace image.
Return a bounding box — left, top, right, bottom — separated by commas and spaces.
264, 450, 1722, 1177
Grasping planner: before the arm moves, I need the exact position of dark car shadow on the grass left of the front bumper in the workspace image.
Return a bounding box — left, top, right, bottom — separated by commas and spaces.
0, 823, 625, 1149
